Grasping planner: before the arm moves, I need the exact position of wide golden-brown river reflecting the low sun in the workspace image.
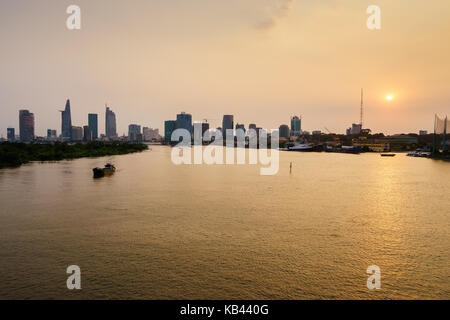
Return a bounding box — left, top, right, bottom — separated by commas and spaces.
0, 146, 450, 299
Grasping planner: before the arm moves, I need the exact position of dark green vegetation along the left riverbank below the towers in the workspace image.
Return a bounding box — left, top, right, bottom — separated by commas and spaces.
0, 142, 148, 168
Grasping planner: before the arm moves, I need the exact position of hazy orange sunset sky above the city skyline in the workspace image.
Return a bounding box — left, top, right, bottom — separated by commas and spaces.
0, 0, 450, 136
